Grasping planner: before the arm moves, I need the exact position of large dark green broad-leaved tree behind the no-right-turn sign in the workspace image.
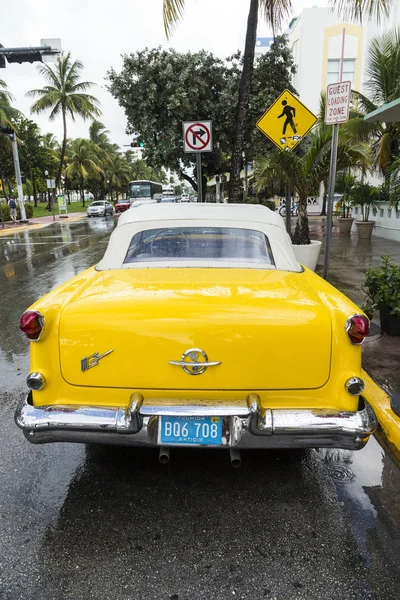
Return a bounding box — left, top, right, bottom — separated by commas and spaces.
108, 48, 237, 199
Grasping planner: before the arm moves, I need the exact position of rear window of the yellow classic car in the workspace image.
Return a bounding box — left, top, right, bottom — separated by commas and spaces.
124, 227, 274, 266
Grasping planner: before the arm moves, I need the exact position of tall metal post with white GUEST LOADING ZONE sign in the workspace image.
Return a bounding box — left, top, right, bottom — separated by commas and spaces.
323, 29, 351, 279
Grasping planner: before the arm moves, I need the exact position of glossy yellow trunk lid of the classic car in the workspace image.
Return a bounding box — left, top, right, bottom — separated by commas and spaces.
59, 268, 331, 391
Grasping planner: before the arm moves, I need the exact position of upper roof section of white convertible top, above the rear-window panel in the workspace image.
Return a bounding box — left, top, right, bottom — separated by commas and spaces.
118, 202, 285, 229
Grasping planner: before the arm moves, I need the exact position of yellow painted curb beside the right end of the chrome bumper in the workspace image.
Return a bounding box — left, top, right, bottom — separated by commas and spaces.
363, 371, 400, 451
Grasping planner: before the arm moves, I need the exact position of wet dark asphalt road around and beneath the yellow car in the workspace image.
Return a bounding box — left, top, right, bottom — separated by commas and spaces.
0, 218, 400, 600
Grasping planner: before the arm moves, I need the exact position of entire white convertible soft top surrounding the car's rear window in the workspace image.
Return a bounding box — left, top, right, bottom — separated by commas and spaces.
96, 203, 302, 272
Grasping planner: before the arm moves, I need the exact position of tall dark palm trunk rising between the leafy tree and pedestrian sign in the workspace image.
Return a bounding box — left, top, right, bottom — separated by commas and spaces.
229, 0, 259, 202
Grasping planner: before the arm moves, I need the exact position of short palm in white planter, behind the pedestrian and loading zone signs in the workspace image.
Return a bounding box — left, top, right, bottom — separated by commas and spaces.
255, 127, 371, 244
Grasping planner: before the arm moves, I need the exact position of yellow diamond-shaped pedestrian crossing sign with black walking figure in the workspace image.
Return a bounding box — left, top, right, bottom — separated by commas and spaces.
257, 90, 317, 152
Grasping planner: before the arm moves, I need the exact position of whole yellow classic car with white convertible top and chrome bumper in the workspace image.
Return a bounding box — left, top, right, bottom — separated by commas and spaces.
15, 204, 376, 464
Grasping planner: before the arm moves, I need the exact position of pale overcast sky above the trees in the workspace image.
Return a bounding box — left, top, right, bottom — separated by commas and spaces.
0, 0, 327, 146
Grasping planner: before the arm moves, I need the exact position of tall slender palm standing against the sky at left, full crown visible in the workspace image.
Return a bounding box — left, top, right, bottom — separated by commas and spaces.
27, 52, 100, 192
